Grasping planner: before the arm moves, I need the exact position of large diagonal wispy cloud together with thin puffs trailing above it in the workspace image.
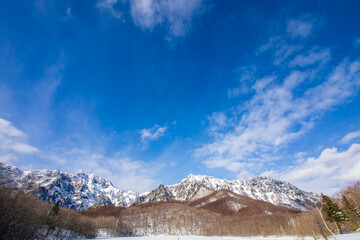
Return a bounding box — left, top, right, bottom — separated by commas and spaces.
194, 20, 360, 175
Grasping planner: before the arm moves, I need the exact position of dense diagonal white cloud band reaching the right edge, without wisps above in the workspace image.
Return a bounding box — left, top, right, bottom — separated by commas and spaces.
194, 56, 360, 172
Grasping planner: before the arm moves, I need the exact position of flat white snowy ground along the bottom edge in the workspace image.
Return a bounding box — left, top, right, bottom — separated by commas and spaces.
79, 232, 360, 240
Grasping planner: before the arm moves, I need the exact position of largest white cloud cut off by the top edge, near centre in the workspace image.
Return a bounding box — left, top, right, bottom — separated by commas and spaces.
130, 0, 202, 36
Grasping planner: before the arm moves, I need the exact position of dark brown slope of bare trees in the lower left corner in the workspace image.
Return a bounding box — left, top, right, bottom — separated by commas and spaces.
0, 186, 96, 239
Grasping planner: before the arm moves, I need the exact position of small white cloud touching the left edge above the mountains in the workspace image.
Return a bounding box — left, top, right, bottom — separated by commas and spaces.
0, 118, 40, 162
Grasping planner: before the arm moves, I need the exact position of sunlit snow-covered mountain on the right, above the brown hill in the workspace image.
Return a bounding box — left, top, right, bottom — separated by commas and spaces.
140, 174, 319, 210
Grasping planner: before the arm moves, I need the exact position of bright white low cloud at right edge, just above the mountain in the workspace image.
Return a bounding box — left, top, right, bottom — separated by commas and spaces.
263, 144, 360, 194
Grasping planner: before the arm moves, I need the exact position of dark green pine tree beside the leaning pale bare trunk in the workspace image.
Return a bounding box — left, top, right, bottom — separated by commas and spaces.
321, 194, 346, 234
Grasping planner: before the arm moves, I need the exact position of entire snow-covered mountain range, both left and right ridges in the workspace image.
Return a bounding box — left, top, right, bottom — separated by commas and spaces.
0, 163, 319, 210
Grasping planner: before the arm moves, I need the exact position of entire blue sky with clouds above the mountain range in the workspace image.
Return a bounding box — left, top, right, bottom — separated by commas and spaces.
0, 0, 360, 194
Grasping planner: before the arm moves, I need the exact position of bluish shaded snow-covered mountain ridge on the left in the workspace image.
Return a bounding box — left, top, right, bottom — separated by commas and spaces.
0, 163, 139, 210
